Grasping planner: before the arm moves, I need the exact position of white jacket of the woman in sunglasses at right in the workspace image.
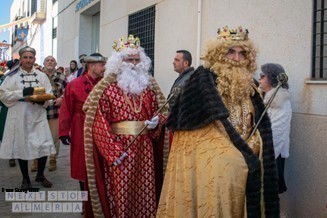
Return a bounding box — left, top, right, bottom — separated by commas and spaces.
264, 88, 292, 158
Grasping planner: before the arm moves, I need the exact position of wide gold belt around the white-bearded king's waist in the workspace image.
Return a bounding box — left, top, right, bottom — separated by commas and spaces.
110, 121, 148, 135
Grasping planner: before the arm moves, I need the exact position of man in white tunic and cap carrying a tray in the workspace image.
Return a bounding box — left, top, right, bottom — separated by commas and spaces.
0, 46, 56, 189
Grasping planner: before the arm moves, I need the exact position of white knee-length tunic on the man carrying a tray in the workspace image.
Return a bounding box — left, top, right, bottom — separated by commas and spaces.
0, 68, 56, 160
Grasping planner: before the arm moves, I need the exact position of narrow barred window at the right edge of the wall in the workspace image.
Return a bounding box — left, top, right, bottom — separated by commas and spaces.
311, 0, 327, 80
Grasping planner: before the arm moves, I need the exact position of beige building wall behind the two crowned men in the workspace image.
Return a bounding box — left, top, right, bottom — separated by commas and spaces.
58, 0, 327, 217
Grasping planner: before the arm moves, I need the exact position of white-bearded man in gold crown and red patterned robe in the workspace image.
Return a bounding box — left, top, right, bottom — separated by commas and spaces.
84, 36, 168, 217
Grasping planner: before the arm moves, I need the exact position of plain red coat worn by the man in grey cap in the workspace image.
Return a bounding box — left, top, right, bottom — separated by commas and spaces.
59, 73, 99, 181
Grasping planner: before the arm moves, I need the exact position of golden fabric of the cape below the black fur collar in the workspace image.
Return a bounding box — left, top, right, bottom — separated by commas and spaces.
157, 121, 248, 218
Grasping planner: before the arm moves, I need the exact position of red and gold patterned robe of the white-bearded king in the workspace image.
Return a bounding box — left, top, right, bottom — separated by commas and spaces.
93, 83, 165, 217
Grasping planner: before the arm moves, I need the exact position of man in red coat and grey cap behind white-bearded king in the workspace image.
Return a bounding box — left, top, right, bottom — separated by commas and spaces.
59, 53, 107, 193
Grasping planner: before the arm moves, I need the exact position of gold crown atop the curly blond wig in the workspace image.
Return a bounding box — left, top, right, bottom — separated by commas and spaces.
217, 26, 249, 41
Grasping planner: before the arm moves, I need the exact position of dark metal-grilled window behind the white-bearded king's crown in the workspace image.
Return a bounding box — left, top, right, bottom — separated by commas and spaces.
128, 6, 156, 75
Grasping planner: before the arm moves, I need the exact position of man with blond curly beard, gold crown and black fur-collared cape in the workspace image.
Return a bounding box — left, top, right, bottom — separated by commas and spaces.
157, 27, 279, 218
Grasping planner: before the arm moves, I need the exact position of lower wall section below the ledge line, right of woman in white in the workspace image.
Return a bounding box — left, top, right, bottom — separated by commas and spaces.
281, 113, 327, 218
